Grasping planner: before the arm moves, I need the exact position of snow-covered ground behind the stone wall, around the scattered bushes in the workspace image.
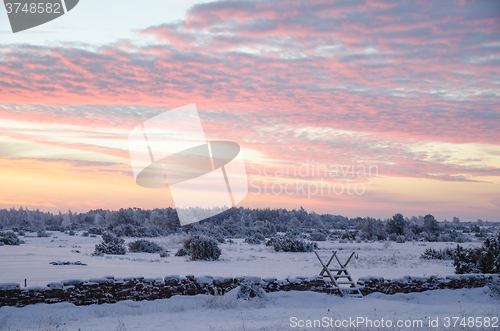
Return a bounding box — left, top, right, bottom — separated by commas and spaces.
0, 232, 480, 286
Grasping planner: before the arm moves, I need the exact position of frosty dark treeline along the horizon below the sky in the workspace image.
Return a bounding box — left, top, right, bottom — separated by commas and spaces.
0, 207, 499, 242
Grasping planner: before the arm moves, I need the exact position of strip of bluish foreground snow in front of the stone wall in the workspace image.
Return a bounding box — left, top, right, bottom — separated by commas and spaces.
0, 288, 500, 331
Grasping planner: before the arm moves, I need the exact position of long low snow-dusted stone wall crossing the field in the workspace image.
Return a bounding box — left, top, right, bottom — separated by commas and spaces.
0, 275, 499, 307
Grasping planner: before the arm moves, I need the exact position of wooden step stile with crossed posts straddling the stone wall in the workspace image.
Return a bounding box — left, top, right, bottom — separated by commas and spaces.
314, 251, 363, 298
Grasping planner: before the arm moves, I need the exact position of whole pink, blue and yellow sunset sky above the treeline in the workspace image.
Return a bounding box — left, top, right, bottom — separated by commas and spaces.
0, 0, 500, 221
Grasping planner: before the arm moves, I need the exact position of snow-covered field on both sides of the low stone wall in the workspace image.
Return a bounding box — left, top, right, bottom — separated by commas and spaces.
0, 232, 500, 331
